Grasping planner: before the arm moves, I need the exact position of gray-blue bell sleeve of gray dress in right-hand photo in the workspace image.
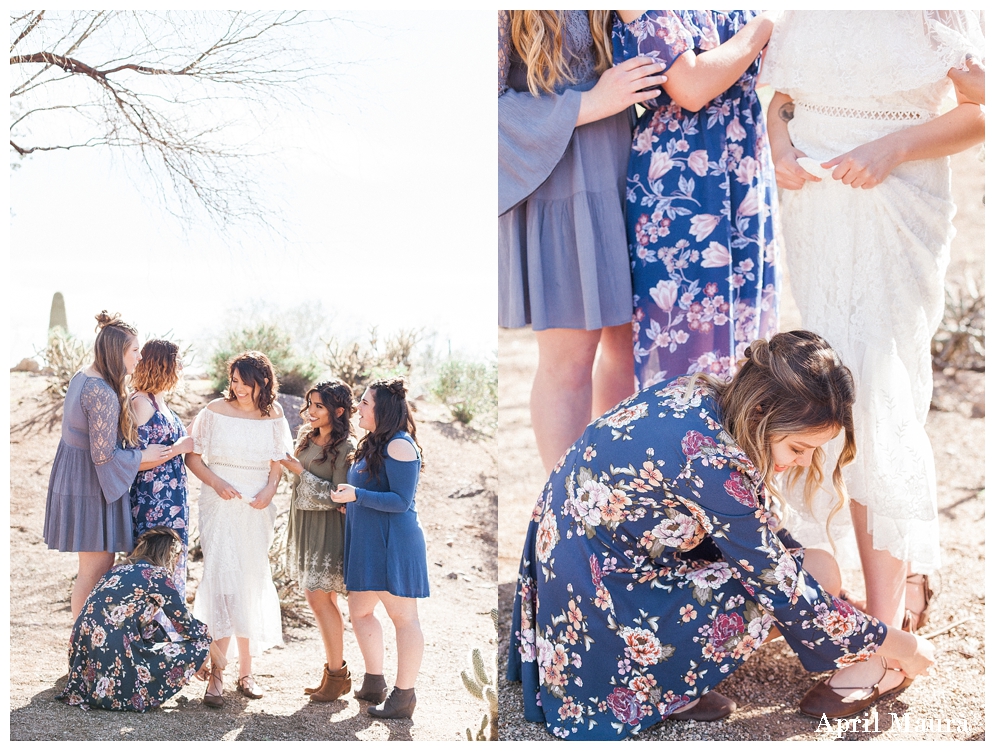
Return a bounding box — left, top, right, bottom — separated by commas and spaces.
498, 11, 581, 216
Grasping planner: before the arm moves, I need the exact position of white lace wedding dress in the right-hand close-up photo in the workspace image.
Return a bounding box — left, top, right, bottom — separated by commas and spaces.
762, 11, 984, 573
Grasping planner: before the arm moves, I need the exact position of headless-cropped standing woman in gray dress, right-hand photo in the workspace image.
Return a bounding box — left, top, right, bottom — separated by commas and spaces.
498, 10, 666, 471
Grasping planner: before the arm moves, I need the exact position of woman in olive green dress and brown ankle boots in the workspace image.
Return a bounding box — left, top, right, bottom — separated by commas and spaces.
281, 379, 356, 701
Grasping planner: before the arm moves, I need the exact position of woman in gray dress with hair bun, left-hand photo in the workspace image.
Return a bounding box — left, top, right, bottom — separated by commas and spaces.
44, 310, 173, 619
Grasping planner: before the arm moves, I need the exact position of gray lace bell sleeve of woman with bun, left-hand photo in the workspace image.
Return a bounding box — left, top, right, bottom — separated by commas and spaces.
80, 378, 142, 503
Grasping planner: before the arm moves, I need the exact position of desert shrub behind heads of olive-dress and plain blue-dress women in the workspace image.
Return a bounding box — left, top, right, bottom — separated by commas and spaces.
325, 326, 421, 396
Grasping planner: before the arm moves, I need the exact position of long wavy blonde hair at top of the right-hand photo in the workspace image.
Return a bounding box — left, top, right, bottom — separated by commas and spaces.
510, 10, 612, 96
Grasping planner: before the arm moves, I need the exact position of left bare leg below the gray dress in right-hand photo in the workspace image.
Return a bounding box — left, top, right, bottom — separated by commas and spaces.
529, 329, 601, 472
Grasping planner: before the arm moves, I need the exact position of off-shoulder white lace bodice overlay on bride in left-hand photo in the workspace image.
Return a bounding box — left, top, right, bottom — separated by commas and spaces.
190, 408, 293, 469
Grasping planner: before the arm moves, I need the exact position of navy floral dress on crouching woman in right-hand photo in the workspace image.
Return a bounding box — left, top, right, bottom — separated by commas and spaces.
508, 377, 886, 740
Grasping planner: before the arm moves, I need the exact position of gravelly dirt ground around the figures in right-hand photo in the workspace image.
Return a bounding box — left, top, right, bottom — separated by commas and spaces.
498, 149, 985, 740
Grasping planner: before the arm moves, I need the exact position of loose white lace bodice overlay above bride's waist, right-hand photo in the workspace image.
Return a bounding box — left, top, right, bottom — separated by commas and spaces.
761, 10, 984, 115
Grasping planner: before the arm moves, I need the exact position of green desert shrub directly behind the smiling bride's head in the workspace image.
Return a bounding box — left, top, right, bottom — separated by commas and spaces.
207, 323, 321, 396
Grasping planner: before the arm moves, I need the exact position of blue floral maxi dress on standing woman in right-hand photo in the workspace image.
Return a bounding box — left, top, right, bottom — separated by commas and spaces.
612, 10, 780, 386
